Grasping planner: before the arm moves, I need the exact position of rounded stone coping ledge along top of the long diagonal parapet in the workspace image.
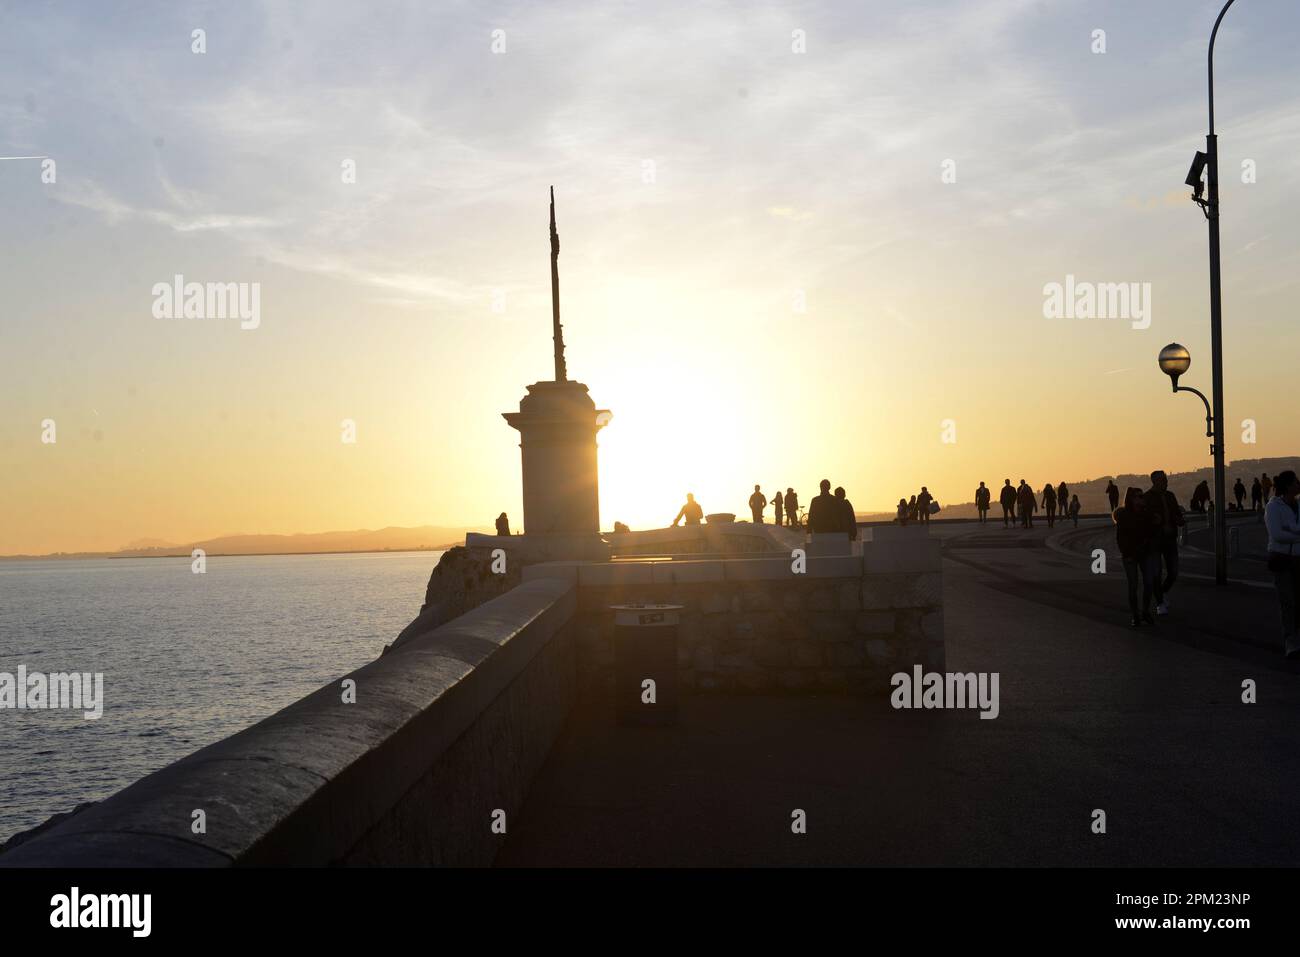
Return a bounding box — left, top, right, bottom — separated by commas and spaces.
0, 580, 576, 867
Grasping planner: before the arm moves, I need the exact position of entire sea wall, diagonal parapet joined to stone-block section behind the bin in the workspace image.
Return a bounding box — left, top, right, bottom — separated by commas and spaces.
0, 527, 944, 867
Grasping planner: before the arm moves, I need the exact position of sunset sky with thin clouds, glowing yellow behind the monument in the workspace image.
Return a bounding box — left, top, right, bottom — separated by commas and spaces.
0, 0, 1300, 554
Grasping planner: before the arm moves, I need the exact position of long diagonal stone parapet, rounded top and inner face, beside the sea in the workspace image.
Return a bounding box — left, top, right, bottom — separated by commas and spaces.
0, 579, 576, 867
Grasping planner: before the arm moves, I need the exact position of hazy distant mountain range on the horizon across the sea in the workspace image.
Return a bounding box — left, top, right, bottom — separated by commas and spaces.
3, 525, 490, 558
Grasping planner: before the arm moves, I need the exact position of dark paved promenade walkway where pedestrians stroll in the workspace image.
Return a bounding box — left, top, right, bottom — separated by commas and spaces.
498, 523, 1300, 866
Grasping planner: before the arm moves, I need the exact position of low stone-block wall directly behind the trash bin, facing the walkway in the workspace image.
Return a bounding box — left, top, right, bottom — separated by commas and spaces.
525, 527, 944, 694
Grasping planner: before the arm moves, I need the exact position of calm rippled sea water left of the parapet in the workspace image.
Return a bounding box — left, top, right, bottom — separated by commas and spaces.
0, 551, 442, 841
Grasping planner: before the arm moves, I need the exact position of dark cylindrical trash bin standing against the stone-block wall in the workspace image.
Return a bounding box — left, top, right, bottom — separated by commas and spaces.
610, 605, 683, 726
